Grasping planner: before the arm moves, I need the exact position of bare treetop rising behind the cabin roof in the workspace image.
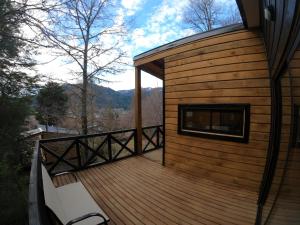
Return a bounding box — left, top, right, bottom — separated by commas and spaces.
183, 0, 241, 32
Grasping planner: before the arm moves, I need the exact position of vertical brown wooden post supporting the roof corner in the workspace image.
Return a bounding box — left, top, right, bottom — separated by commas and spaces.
134, 67, 142, 154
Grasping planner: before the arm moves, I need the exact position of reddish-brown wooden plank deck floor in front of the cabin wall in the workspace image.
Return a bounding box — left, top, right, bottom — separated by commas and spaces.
83, 159, 255, 224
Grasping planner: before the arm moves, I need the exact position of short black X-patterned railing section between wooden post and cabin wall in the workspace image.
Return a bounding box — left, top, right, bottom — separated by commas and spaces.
142, 125, 164, 152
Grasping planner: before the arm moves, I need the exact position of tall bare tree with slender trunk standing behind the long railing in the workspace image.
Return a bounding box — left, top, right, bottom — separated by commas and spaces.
39, 0, 126, 134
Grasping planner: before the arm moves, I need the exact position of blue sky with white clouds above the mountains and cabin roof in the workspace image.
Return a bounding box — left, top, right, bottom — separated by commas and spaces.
32, 0, 239, 90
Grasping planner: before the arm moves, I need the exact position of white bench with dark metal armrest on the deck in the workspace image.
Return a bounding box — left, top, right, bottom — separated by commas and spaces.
42, 165, 109, 225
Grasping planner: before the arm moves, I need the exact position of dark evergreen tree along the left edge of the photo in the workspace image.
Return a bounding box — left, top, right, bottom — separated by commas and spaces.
0, 0, 36, 225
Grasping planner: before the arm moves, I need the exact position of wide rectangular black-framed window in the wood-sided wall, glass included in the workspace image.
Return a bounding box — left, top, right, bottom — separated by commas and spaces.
178, 104, 250, 142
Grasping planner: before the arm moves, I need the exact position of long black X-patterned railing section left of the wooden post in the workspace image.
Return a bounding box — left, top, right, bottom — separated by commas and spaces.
39, 129, 137, 174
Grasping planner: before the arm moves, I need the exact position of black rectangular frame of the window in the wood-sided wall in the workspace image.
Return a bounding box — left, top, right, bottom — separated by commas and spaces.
177, 104, 250, 143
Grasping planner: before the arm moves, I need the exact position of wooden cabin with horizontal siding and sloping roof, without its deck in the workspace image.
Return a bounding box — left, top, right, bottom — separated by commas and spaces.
134, 0, 300, 224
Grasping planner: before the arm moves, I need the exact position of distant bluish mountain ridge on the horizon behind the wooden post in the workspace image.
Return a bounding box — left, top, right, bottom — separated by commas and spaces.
63, 84, 162, 110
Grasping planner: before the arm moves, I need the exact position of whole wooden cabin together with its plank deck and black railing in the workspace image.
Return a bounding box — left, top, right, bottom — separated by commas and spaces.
29, 0, 300, 225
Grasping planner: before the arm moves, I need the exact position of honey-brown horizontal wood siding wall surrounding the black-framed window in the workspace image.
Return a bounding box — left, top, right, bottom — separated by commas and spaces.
163, 30, 270, 192
